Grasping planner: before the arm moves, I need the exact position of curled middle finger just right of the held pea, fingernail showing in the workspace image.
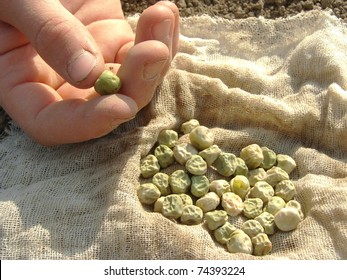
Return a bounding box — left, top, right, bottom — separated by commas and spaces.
117, 40, 170, 109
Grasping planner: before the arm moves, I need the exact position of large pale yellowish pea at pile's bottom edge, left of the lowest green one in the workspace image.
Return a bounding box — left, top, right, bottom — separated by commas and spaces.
227, 229, 253, 254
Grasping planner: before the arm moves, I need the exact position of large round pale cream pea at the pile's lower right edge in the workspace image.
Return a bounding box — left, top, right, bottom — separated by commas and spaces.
275, 207, 301, 231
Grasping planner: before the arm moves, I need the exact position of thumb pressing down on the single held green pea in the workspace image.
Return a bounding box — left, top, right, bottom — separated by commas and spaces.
0, 0, 104, 88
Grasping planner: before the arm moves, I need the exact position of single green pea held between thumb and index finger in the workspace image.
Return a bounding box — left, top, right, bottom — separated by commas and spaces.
94, 70, 122, 95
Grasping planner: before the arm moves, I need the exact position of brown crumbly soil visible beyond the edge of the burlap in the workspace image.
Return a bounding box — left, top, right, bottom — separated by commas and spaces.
0, 0, 347, 139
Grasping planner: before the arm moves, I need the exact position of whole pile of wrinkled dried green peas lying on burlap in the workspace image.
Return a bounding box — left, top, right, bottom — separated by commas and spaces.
137, 119, 304, 256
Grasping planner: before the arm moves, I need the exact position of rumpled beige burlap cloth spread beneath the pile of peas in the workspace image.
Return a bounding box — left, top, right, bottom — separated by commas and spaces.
0, 11, 347, 259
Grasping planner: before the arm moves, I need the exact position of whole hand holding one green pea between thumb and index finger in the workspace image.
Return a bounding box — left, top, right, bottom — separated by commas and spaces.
0, 0, 179, 146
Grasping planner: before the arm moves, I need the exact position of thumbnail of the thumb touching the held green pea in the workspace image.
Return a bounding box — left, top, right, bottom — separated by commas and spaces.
67, 51, 96, 82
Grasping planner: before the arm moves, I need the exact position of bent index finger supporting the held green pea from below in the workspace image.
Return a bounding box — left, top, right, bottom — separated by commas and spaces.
3, 83, 138, 146
